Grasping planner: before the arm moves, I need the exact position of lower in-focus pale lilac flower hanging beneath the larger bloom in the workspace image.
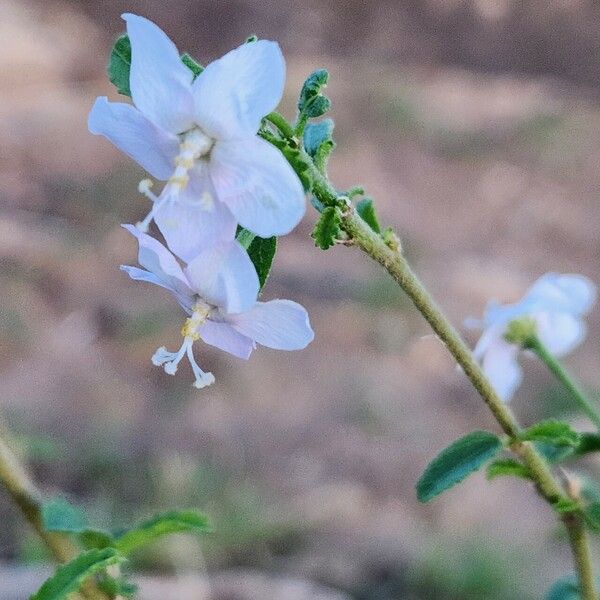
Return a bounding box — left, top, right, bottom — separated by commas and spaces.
121, 225, 314, 388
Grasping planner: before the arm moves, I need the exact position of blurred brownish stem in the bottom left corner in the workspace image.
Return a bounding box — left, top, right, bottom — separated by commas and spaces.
0, 438, 107, 600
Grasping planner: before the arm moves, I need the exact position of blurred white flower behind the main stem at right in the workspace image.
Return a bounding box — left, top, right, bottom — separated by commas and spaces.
469, 273, 596, 402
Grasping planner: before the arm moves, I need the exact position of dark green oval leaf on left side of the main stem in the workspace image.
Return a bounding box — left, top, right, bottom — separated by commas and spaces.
417, 431, 502, 502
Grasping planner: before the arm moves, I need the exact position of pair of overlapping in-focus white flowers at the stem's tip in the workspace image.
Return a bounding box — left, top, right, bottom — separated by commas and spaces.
88, 14, 313, 388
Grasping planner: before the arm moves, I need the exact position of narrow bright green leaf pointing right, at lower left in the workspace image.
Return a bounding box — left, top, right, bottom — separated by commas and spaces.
115, 510, 210, 554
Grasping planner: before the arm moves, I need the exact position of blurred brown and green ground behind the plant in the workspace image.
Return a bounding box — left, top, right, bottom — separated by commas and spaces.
0, 0, 600, 600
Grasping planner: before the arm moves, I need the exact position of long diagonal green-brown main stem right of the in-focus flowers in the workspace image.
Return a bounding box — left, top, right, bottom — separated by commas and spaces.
266, 115, 597, 600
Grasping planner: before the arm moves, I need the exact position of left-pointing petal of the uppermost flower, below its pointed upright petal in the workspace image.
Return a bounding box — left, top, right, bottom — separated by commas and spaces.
88, 96, 179, 180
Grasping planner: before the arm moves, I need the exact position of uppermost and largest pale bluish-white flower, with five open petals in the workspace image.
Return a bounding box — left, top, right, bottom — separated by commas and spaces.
88, 14, 305, 258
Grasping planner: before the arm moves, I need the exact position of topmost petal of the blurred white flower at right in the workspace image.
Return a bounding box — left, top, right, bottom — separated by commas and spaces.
525, 273, 597, 315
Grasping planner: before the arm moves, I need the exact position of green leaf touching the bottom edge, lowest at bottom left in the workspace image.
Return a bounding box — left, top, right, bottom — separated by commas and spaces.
29, 548, 125, 600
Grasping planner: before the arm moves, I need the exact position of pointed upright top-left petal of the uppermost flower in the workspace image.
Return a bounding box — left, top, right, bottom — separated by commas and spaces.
122, 13, 194, 133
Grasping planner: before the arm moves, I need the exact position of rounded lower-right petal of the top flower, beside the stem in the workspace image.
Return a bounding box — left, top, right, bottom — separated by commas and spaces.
210, 137, 306, 237
